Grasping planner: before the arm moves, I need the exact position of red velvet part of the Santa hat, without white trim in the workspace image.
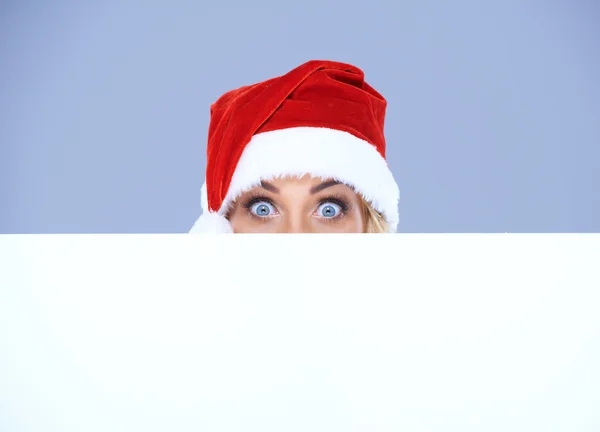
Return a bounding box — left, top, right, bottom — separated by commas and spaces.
206, 60, 387, 211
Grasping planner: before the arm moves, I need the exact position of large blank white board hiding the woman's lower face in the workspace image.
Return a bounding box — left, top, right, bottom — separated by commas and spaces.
0, 234, 600, 432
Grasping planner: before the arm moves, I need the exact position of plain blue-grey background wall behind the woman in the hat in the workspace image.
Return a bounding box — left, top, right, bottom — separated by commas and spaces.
0, 0, 600, 233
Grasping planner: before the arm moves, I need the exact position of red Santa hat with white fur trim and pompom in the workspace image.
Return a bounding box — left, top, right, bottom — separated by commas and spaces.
190, 60, 400, 233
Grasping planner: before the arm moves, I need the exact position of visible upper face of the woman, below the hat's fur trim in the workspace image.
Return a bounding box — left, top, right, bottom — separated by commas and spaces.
227, 175, 388, 233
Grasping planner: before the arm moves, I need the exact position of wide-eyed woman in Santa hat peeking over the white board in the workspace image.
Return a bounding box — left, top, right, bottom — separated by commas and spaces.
190, 61, 400, 233
